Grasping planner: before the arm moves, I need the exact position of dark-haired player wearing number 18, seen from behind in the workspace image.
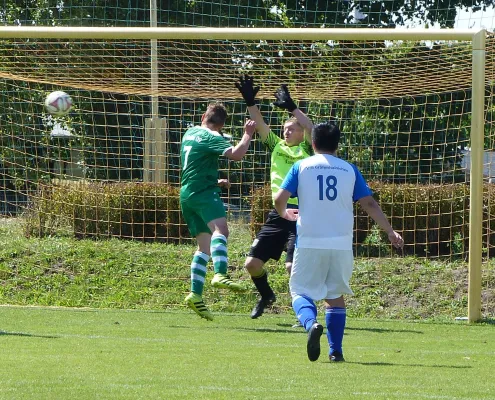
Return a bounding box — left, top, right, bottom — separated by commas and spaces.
275, 123, 404, 361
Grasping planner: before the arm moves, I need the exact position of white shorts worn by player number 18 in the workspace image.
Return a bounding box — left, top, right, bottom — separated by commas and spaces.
289, 247, 354, 300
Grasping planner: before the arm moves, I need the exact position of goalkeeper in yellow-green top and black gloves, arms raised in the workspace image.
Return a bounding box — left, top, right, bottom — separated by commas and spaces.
235, 75, 313, 318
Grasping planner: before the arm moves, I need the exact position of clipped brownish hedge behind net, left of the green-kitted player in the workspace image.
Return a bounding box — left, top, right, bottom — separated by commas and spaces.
24, 181, 189, 243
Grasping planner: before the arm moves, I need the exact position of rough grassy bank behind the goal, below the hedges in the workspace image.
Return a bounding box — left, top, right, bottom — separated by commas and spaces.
0, 219, 495, 320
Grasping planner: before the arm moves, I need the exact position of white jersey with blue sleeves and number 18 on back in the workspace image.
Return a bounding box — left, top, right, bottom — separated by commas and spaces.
281, 154, 372, 250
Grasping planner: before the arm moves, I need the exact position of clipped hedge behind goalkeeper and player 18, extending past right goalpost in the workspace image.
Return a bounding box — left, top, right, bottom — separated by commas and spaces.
250, 182, 495, 258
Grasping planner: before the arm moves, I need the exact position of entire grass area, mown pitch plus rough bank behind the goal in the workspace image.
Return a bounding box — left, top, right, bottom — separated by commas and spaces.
0, 219, 495, 400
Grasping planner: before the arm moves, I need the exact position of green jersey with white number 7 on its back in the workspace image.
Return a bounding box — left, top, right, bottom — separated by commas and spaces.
180, 126, 232, 200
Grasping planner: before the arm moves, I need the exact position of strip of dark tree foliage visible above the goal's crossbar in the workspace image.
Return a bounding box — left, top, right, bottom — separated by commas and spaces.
0, 0, 495, 28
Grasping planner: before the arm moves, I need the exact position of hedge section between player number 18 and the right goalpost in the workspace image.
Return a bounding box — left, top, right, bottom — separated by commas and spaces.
355, 182, 469, 257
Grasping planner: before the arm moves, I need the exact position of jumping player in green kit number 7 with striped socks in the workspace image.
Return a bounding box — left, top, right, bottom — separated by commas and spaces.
180, 103, 256, 321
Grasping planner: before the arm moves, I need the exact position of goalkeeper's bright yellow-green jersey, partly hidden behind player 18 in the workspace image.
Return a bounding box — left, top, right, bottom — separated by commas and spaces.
263, 131, 313, 205
